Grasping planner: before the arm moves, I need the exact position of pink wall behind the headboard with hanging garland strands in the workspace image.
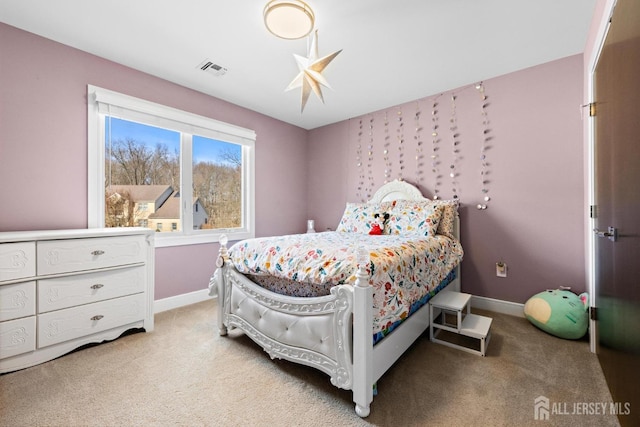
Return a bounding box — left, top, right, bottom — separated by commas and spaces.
308, 55, 586, 302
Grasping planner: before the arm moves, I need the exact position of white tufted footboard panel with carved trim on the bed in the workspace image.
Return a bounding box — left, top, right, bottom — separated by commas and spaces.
218, 266, 353, 389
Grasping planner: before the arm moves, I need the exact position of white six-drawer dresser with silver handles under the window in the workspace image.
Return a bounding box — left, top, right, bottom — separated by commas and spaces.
0, 228, 154, 373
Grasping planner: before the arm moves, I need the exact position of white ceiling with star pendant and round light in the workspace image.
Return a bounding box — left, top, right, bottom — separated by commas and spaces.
0, 0, 596, 129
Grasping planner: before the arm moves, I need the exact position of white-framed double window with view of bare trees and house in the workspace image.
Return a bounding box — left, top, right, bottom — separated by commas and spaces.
88, 86, 255, 246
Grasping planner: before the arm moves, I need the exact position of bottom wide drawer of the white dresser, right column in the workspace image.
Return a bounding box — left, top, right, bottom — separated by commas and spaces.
38, 294, 146, 348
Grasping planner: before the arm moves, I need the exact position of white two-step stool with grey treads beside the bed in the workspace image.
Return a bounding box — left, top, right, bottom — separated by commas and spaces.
429, 291, 493, 356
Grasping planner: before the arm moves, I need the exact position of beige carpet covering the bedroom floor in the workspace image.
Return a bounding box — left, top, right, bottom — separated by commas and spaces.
0, 300, 618, 426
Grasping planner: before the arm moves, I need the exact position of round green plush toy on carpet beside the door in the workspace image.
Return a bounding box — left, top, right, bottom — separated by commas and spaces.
524, 289, 589, 340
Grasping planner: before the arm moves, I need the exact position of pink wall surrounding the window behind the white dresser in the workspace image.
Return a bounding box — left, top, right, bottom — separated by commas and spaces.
0, 23, 307, 299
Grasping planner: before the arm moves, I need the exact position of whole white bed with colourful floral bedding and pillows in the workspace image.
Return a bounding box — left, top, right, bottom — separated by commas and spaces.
209, 181, 463, 417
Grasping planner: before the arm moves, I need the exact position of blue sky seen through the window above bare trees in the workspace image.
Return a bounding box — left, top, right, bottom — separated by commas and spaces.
105, 117, 242, 163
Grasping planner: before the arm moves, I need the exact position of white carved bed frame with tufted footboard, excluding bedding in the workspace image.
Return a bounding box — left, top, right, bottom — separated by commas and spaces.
209, 181, 460, 417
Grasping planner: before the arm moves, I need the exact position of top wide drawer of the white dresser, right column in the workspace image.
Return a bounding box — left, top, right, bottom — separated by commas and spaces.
37, 236, 147, 276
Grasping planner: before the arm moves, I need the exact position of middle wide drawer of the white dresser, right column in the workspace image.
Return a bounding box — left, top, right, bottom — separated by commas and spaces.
38, 266, 147, 313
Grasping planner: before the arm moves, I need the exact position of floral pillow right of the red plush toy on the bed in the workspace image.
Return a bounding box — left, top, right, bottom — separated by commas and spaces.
386, 200, 444, 236
